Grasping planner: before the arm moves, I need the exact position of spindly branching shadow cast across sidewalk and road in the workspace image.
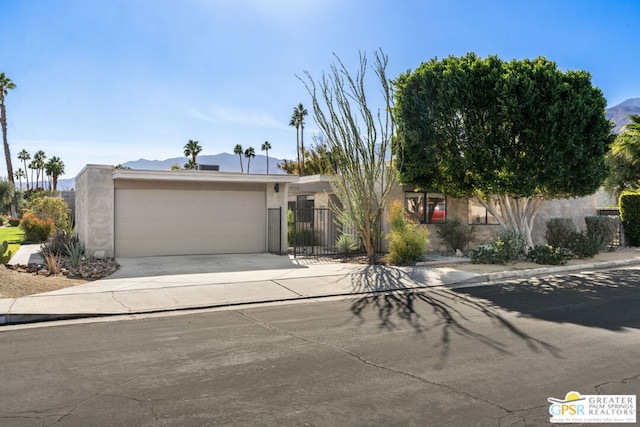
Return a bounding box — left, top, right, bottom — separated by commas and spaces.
350, 265, 562, 365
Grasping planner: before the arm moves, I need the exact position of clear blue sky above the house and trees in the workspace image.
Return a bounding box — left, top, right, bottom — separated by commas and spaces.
0, 0, 640, 178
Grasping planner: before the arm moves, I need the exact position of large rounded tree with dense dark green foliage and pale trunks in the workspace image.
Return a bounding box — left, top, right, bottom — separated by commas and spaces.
394, 53, 612, 245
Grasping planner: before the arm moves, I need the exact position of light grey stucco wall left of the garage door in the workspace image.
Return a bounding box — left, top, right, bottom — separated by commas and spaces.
76, 165, 114, 258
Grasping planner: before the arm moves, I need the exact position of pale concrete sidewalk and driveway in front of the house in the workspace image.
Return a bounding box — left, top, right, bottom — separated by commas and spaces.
0, 248, 640, 325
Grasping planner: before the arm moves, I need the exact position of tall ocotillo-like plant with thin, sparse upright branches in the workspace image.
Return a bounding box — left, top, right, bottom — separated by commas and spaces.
305, 51, 395, 261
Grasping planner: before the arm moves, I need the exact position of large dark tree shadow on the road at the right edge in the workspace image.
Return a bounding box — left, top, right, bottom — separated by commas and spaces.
456, 269, 640, 331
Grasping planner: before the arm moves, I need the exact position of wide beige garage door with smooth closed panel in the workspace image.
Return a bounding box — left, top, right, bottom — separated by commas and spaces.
115, 188, 266, 257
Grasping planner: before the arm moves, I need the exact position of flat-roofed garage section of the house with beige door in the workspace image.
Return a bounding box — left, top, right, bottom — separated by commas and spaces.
75, 165, 298, 257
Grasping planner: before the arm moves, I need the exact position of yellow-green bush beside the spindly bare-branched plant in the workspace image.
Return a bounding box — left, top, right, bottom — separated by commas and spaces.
386, 200, 429, 265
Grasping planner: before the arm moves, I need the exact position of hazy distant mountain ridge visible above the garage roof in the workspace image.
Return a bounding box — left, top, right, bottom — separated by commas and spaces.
122, 153, 284, 175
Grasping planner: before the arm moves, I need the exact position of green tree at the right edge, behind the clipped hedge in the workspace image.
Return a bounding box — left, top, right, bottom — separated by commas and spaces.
605, 116, 640, 196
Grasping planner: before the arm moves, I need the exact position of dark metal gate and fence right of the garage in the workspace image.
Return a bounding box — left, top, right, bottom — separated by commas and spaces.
287, 208, 362, 256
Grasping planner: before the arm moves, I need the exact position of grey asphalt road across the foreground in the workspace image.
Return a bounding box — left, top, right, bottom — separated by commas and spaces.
0, 269, 640, 426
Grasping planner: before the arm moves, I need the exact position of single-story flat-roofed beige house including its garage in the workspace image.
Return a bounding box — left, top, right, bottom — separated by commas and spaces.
75, 165, 597, 257
